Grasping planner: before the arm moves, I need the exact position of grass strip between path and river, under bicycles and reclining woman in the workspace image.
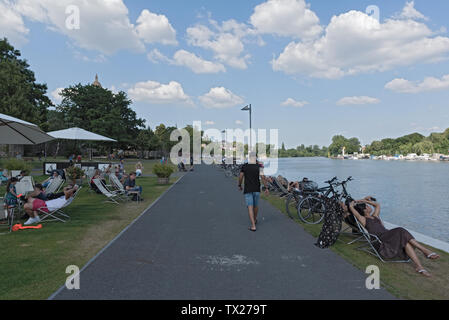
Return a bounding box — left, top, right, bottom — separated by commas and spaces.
263, 195, 449, 300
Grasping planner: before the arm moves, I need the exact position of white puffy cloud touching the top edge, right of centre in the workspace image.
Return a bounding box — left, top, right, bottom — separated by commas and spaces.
250, 0, 323, 39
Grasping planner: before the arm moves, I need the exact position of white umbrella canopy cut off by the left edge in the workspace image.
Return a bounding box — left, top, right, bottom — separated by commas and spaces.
0, 113, 54, 145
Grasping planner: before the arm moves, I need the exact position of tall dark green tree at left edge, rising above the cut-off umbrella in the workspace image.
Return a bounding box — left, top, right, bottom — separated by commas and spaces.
0, 38, 52, 130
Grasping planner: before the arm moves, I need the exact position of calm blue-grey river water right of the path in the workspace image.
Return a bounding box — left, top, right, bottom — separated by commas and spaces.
264, 158, 449, 242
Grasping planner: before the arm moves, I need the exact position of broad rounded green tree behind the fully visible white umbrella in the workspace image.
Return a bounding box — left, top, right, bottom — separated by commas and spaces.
57, 84, 145, 148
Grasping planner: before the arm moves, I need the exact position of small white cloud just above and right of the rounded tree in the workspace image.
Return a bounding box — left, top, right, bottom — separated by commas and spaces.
128, 81, 192, 104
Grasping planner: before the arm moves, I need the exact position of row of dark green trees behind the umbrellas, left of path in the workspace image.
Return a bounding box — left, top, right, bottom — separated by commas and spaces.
0, 38, 198, 158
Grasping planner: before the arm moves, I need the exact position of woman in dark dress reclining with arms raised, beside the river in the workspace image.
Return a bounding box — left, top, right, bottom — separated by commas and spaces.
349, 197, 440, 277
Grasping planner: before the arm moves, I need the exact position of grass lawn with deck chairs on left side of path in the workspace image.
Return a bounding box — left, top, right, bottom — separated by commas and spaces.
0, 177, 177, 300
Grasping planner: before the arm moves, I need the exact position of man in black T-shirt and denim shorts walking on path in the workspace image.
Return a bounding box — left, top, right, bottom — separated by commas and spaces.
239, 152, 269, 232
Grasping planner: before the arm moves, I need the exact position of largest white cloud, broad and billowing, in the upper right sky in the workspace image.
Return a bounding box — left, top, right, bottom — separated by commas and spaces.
272, 3, 449, 79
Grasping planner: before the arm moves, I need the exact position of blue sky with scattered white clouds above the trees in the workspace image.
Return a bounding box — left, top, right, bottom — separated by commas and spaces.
0, 0, 449, 147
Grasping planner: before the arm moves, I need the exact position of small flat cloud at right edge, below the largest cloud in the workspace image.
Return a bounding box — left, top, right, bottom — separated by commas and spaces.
385, 74, 449, 93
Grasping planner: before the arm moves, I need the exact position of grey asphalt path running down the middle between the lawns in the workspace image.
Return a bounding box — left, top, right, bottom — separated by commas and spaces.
51, 165, 393, 300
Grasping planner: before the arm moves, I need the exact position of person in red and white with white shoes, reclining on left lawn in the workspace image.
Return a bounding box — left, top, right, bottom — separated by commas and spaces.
23, 185, 78, 226
